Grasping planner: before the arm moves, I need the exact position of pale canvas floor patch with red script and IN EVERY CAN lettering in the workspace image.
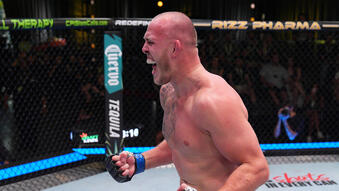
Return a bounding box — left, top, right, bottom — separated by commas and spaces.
257, 162, 339, 191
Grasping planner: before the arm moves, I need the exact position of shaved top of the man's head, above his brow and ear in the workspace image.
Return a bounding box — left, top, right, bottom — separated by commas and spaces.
150, 12, 197, 46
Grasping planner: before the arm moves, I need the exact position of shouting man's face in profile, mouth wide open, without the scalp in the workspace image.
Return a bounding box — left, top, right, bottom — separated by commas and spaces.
142, 23, 172, 85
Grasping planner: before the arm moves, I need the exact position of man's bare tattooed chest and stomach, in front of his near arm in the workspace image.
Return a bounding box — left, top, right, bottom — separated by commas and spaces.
162, 75, 236, 190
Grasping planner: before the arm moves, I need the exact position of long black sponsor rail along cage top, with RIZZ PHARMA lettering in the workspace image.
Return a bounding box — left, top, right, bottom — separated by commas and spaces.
0, 18, 339, 31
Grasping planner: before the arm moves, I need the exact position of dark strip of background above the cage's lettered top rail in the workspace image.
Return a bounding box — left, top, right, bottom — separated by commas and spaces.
3, 0, 339, 20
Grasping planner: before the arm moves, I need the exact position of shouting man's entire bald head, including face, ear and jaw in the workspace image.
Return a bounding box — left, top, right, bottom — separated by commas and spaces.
142, 12, 202, 85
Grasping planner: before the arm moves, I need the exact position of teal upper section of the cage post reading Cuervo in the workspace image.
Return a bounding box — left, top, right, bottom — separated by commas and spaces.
104, 34, 123, 94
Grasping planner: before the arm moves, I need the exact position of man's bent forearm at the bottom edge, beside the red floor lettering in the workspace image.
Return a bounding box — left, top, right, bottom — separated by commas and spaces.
218, 162, 268, 191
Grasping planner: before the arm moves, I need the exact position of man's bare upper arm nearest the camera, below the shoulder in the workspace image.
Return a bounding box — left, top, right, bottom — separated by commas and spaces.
196, 97, 262, 163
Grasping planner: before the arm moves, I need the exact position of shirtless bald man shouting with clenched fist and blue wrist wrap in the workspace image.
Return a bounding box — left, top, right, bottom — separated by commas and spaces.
109, 12, 269, 191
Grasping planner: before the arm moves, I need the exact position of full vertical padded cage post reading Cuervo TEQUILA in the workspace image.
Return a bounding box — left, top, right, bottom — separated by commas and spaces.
104, 32, 123, 155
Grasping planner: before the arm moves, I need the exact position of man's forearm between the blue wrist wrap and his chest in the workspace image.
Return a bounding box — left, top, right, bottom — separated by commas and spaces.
142, 140, 172, 169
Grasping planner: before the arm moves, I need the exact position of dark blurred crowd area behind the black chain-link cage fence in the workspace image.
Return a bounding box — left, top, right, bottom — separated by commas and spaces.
0, 0, 339, 188
